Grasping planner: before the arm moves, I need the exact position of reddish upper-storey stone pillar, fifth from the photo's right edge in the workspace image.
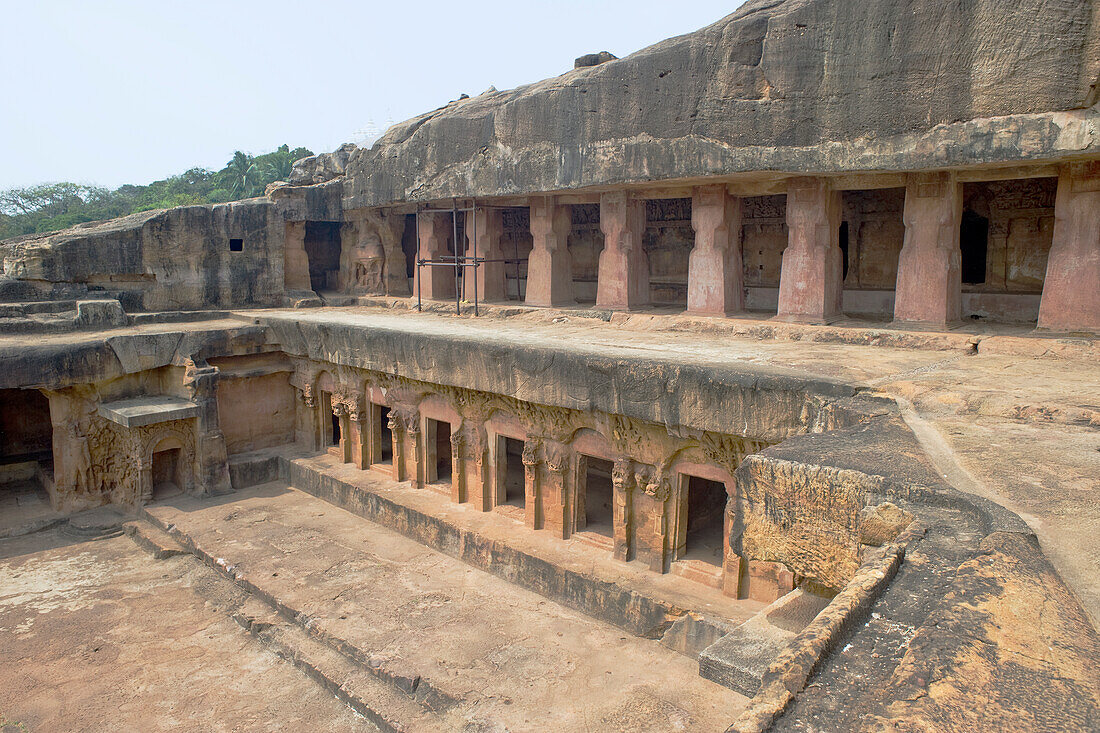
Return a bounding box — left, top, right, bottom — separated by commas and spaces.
596, 190, 649, 309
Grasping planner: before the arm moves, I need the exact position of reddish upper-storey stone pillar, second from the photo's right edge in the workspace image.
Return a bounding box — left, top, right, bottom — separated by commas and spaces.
894, 173, 963, 327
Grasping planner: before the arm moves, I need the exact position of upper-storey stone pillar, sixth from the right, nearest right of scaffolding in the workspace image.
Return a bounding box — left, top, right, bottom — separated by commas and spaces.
526, 196, 576, 306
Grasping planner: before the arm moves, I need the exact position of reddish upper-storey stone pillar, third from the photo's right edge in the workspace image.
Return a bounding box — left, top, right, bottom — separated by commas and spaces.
777, 178, 844, 322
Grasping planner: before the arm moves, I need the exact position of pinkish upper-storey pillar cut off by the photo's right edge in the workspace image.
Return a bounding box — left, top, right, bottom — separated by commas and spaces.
1038, 162, 1100, 331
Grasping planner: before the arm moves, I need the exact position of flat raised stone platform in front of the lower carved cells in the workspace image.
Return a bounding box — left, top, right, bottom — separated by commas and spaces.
139, 483, 746, 732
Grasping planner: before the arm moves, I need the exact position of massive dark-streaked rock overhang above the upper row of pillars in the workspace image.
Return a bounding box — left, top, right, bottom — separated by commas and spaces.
341, 0, 1100, 208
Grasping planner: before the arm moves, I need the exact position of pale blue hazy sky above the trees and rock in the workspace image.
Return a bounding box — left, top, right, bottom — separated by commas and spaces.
0, 0, 740, 188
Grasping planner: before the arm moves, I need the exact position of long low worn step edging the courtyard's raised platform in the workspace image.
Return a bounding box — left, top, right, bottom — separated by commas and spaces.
141, 511, 477, 731
